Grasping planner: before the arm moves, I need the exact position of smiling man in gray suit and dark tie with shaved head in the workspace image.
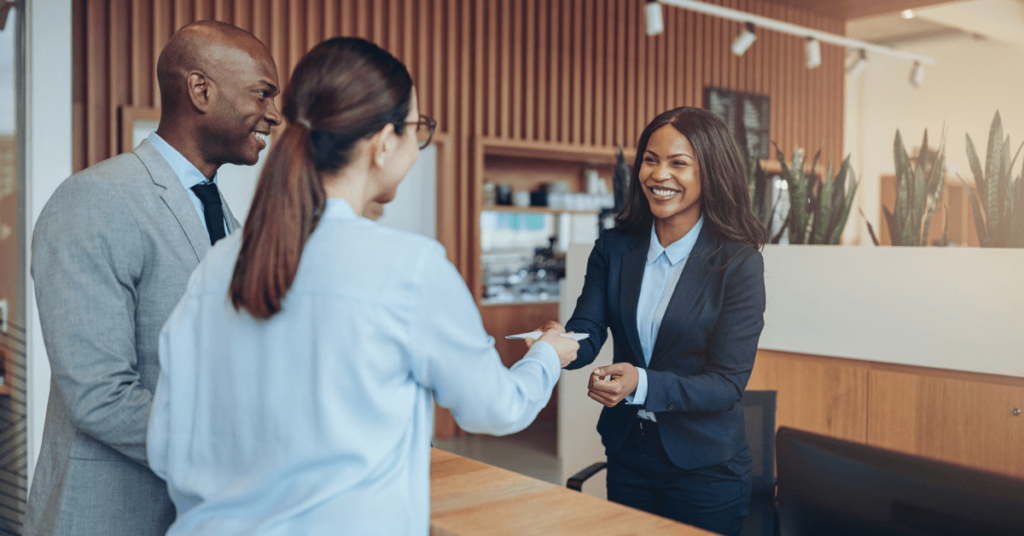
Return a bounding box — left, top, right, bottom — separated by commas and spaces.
26, 20, 282, 536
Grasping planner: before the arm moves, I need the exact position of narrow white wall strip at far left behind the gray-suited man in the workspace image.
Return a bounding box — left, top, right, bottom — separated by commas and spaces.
23, 0, 72, 487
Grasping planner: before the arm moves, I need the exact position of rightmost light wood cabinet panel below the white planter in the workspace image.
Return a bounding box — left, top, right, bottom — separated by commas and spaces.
867, 370, 1024, 478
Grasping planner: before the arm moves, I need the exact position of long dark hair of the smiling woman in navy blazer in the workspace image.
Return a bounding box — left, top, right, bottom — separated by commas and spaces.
615, 107, 767, 253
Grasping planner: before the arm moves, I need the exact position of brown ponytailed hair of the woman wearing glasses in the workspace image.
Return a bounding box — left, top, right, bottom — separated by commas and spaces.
230, 38, 413, 320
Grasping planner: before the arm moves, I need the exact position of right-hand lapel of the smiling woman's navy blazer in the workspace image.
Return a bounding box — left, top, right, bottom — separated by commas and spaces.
650, 224, 719, 367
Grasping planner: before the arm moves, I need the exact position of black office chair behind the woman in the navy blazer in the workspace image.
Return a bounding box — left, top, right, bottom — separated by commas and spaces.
565, 390, 776, 536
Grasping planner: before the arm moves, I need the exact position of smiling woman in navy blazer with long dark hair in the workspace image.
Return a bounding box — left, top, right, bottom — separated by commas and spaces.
549, 108, 765, 534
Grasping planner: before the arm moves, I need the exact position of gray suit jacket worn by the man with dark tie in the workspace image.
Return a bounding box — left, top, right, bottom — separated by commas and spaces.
26, 141, 239, 536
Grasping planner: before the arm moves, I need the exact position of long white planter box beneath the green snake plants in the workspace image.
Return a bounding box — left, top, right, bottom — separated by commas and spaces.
760, 245, 1024, 376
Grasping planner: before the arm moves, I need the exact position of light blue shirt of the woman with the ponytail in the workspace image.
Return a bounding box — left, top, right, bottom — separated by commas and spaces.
146, 199, 561, 536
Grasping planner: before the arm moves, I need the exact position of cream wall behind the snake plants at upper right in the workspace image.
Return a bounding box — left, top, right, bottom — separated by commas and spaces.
845, 32, 1024, 245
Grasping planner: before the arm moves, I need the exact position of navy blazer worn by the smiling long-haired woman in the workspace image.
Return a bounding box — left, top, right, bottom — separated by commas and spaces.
565, 224, 765, 469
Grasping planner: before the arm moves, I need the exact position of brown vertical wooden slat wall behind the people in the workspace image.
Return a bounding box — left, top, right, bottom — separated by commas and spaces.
73, 0, 845, 282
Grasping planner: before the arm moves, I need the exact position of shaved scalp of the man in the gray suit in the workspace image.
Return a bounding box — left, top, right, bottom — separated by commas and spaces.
157, 20, 272, 110
